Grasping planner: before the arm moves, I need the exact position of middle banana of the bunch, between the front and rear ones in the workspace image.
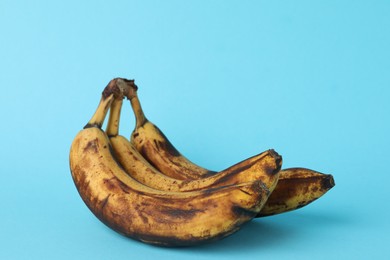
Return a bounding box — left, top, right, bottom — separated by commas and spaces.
106, 99, 282, 192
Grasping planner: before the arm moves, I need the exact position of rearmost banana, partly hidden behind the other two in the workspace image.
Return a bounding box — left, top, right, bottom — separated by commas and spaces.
128, 84, 335, 217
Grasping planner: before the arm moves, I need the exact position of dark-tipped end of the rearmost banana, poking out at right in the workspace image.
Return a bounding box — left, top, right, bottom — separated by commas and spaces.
258, 168, 335, 217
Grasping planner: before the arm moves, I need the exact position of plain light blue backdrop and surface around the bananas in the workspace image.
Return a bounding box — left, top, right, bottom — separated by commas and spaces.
0, 0, 390, 259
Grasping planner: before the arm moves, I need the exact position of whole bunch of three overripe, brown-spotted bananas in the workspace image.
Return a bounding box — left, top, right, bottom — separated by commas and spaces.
69, 78, 334, 246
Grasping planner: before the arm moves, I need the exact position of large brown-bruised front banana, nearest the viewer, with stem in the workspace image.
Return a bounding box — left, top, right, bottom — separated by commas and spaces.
69, 78, 269, 246
